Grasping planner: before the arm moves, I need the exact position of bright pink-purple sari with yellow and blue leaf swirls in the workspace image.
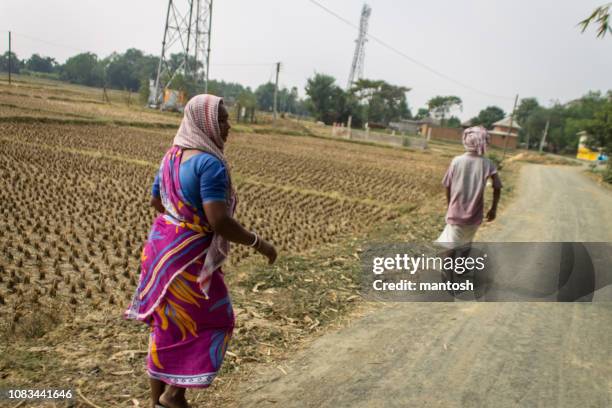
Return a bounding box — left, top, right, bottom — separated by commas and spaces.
125, 146, 234, 387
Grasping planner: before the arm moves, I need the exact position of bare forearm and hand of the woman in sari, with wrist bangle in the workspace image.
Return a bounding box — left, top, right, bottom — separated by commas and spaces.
204, 201, 277, 264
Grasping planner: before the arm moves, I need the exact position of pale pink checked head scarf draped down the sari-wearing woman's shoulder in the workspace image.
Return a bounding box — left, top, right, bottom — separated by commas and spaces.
173, 95, 238, 283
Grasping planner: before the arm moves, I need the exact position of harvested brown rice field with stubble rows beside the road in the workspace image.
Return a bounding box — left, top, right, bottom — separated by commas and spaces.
0, 75, 488, 407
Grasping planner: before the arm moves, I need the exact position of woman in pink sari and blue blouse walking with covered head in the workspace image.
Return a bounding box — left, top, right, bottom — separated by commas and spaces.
125, 95, 276, 408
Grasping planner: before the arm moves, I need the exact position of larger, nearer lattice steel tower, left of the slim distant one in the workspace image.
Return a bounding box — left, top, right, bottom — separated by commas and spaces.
149, 0, 213, 106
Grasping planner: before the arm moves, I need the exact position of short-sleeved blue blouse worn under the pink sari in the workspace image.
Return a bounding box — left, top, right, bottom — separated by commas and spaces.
152, 153, 229, 213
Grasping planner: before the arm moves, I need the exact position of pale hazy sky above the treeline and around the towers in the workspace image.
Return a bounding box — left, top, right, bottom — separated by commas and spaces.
0, 0, 612, 119
